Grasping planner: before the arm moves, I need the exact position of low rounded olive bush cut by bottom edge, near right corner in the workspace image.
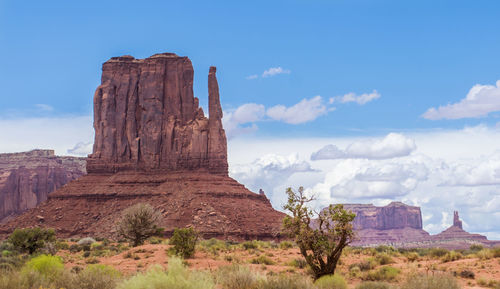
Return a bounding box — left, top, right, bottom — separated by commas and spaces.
401, 274, 460, 289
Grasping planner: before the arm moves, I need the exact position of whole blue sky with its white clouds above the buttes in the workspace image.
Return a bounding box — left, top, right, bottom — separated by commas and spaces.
0, 0, 500, 238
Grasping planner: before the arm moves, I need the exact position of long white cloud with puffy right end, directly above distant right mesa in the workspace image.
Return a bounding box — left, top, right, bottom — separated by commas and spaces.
311, 133, 417, 160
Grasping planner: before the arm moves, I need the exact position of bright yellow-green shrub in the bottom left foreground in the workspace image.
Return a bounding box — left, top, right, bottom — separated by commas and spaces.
21, 255, 64, 281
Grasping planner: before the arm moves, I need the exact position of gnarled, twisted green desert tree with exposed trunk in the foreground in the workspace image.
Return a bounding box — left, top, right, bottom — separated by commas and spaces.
283, 187, 356, 279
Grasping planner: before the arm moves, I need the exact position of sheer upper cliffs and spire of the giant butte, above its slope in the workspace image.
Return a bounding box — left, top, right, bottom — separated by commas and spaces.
87, 53, 228, 176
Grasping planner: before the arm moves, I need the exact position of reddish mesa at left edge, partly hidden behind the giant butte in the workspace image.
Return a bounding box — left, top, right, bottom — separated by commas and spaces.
0, 150, 85, 222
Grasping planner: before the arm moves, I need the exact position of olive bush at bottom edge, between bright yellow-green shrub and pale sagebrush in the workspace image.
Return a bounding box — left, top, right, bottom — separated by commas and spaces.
72, 265, 120, 289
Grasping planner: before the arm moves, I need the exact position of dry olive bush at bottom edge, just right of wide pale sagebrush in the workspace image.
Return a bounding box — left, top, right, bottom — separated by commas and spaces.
216, 265, 263, 289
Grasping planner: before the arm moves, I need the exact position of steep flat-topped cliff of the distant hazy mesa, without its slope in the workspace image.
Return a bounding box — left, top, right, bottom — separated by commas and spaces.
344, 202, 422, 230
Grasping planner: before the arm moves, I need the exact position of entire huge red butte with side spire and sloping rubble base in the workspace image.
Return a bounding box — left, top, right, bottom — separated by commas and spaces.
0, 53, 283, 240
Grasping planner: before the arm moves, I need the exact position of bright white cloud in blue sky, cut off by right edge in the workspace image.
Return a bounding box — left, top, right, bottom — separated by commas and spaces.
422, 80, 500, 120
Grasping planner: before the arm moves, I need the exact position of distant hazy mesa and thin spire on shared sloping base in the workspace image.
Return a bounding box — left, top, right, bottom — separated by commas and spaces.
334, 202, 500, 249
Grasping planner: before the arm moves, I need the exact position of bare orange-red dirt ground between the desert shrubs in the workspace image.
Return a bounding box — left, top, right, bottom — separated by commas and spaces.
58, 242, 500, 288
